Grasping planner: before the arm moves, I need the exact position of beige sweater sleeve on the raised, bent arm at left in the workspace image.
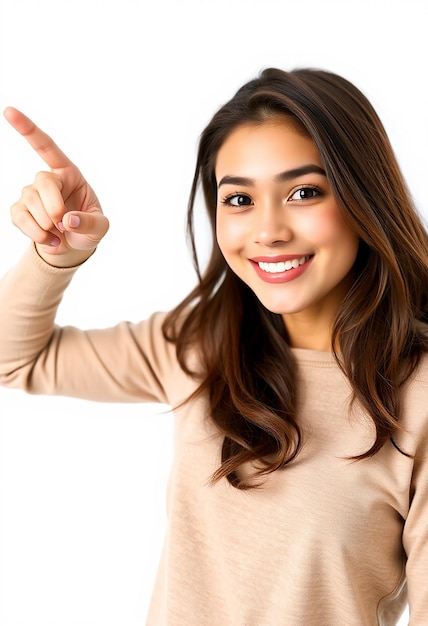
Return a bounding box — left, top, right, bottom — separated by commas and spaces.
0, 241, 178, 404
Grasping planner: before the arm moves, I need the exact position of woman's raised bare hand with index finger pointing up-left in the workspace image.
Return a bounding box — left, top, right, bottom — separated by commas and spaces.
4, 107, 109, 267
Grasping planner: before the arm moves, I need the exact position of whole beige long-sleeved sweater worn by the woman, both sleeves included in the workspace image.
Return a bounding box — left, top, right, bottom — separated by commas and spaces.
0, 248, 428, 626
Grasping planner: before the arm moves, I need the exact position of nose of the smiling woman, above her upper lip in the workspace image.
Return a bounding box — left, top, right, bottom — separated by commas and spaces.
254, 202, 293, 246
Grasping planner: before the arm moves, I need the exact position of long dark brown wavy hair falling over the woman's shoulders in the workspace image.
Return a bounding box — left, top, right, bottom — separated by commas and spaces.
163, 68, 428, 489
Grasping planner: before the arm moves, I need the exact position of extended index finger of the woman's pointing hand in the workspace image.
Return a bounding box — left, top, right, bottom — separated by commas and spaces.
4, 107, 73, 170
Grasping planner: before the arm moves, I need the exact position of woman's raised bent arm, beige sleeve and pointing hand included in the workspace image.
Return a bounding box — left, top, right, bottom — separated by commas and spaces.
0, 108, 177, 403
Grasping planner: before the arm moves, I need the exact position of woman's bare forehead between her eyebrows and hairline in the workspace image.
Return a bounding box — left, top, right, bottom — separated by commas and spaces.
216, 118, 322, 179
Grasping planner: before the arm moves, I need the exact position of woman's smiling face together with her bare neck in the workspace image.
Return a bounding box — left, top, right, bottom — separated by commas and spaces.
216, 118, 358, 349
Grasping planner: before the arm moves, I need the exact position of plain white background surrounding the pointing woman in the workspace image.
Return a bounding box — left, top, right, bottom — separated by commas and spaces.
0, 0, 428, 626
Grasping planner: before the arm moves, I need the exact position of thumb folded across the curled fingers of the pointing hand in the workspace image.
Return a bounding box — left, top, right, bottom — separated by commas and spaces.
58, 211, 109, 250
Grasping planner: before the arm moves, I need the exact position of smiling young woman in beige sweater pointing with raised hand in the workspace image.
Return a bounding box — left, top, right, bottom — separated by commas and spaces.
0, 69, 428, 626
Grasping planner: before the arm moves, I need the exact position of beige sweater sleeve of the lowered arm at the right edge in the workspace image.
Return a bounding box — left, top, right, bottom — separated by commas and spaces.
403, 359, 428, 626
